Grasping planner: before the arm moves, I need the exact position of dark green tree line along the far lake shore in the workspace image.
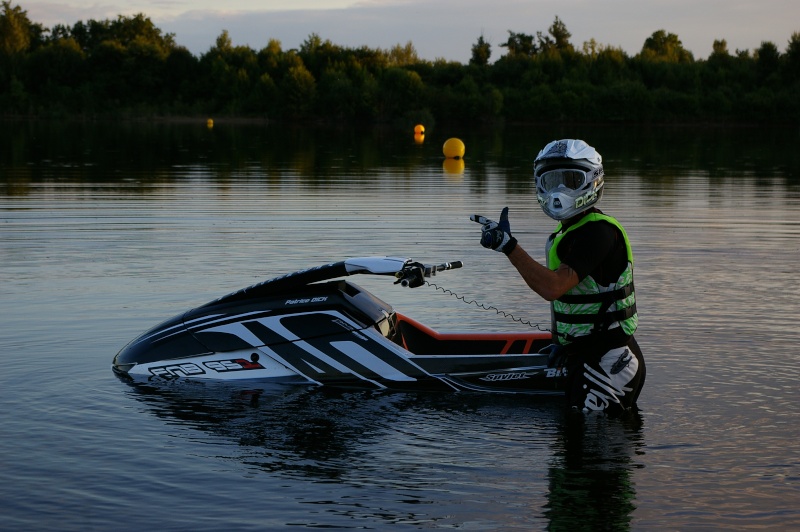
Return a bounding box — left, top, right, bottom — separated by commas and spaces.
0, 0, 800, 124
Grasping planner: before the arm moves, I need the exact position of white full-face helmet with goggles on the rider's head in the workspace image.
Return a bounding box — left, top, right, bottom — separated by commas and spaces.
533, 139, 603, 220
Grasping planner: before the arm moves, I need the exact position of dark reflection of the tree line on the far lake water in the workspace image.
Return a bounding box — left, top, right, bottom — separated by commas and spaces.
0, 120, 800, 195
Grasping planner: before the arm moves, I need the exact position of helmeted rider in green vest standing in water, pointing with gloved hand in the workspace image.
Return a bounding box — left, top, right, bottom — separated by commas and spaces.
472, 139, 645, 413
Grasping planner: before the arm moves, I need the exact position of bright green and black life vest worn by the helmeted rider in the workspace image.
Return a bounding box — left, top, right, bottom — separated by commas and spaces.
547, 212, 639, 345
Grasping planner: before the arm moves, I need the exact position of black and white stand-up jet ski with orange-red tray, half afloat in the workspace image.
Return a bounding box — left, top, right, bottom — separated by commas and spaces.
112, 257, 565, 394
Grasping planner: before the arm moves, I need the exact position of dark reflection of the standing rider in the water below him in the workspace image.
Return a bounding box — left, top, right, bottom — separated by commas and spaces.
545, 412, 643, 531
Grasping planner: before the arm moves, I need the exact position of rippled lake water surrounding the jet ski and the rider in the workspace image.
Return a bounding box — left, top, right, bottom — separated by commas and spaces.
0, 121, 800, 530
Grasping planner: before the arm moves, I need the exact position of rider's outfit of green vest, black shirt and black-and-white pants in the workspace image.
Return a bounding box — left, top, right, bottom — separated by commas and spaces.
547, 209, 645, 413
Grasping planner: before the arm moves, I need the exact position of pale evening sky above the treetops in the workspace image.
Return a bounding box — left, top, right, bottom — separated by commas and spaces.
17, 0, 800, 63
